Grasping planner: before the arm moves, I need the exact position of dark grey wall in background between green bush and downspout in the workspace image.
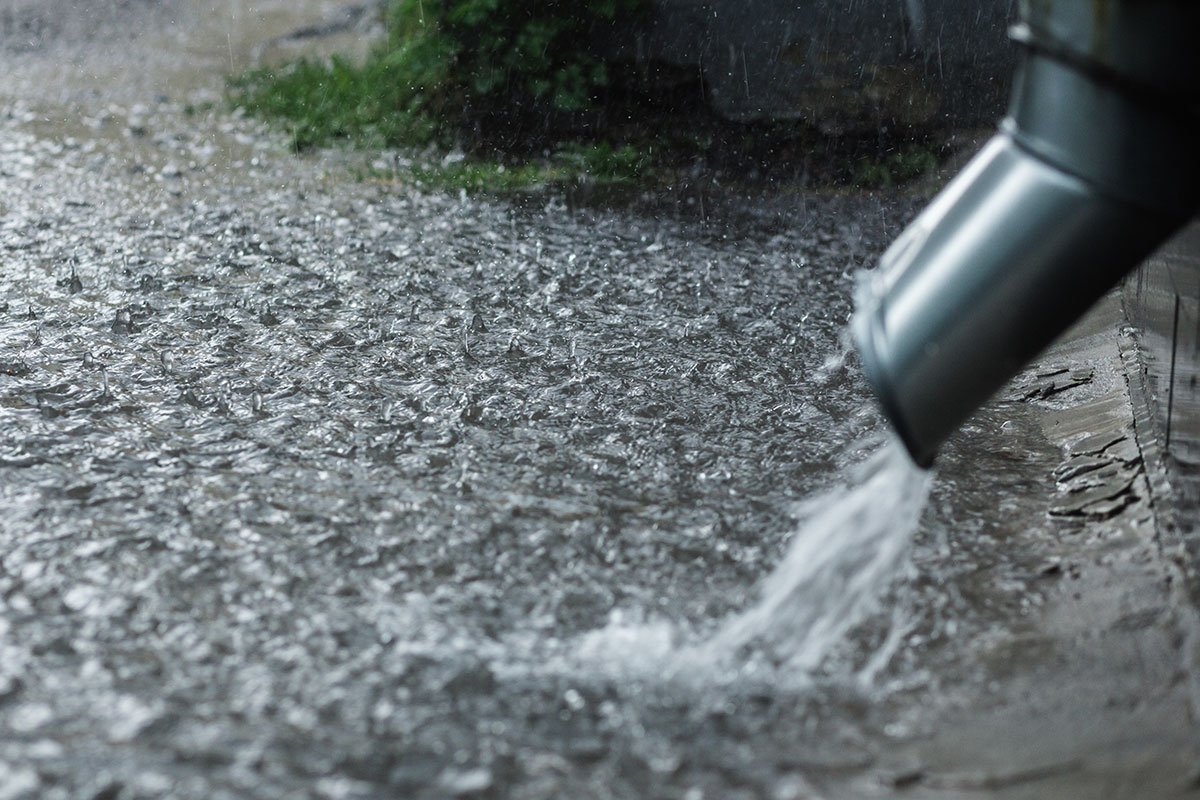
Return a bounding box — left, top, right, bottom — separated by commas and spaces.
634, 0, 1015, 132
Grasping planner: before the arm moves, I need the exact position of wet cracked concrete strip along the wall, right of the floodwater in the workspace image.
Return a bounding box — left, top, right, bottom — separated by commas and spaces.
901, 302, 1200, 798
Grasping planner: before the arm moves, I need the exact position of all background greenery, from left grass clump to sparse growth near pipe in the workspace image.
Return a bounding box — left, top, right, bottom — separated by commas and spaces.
228, 0, 937, 193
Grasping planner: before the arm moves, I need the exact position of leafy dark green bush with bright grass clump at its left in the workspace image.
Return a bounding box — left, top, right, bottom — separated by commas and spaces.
229, 0, 648, 149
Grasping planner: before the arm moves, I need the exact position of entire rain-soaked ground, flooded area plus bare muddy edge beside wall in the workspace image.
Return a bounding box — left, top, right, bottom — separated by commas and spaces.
0, 0, 1200, 800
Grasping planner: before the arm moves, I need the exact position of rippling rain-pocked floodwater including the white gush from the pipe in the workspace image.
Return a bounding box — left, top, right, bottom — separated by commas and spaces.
0, 3, 1051, 799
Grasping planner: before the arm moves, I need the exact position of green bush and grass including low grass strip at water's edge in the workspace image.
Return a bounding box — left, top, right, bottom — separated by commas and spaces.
228, 0, 654, 192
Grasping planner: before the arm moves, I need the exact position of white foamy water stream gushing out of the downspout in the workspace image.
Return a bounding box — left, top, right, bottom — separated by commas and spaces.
563, 441, 930, 682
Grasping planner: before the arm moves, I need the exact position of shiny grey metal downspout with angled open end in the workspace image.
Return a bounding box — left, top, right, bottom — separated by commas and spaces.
853, 0, 1200, 467
